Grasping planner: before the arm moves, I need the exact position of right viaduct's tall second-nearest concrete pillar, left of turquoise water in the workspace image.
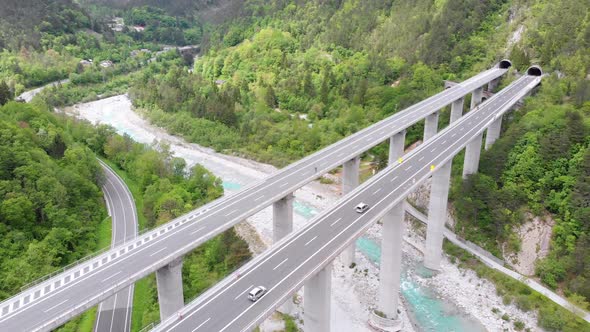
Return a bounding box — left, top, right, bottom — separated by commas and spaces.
379, 202, 404, 319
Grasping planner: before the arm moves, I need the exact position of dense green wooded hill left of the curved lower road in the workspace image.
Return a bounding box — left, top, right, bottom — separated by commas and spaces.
0, 103, 106, 299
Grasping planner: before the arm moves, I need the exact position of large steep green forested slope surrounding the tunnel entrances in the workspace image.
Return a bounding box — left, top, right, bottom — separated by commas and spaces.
130, 0, 590, 316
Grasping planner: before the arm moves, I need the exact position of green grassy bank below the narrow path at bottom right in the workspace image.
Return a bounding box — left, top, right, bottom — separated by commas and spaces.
443, 239, 590, 332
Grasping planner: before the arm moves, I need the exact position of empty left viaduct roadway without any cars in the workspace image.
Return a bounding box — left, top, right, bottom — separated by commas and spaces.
0, 68, 506, 330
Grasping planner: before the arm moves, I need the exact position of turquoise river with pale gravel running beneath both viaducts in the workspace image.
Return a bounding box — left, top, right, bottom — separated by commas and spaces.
66, 96, 485, 332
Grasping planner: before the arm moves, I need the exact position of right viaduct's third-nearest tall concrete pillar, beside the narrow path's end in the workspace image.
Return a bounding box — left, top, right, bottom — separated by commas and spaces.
424, 161, 452, 270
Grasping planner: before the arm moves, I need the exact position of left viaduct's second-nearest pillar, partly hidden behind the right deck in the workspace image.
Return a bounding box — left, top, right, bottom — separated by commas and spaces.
272, 193, 295, 314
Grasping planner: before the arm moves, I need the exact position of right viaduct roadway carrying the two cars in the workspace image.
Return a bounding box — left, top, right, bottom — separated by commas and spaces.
154, 76, 540, 332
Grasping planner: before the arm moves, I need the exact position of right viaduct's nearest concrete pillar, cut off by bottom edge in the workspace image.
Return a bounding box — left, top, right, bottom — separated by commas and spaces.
303, 263, 332, 332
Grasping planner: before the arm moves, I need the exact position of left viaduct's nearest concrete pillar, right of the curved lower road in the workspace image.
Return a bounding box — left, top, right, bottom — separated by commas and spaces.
156, 257, 184, 320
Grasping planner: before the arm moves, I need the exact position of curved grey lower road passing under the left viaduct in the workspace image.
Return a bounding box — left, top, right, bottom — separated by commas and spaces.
94, 161, 138, 332
